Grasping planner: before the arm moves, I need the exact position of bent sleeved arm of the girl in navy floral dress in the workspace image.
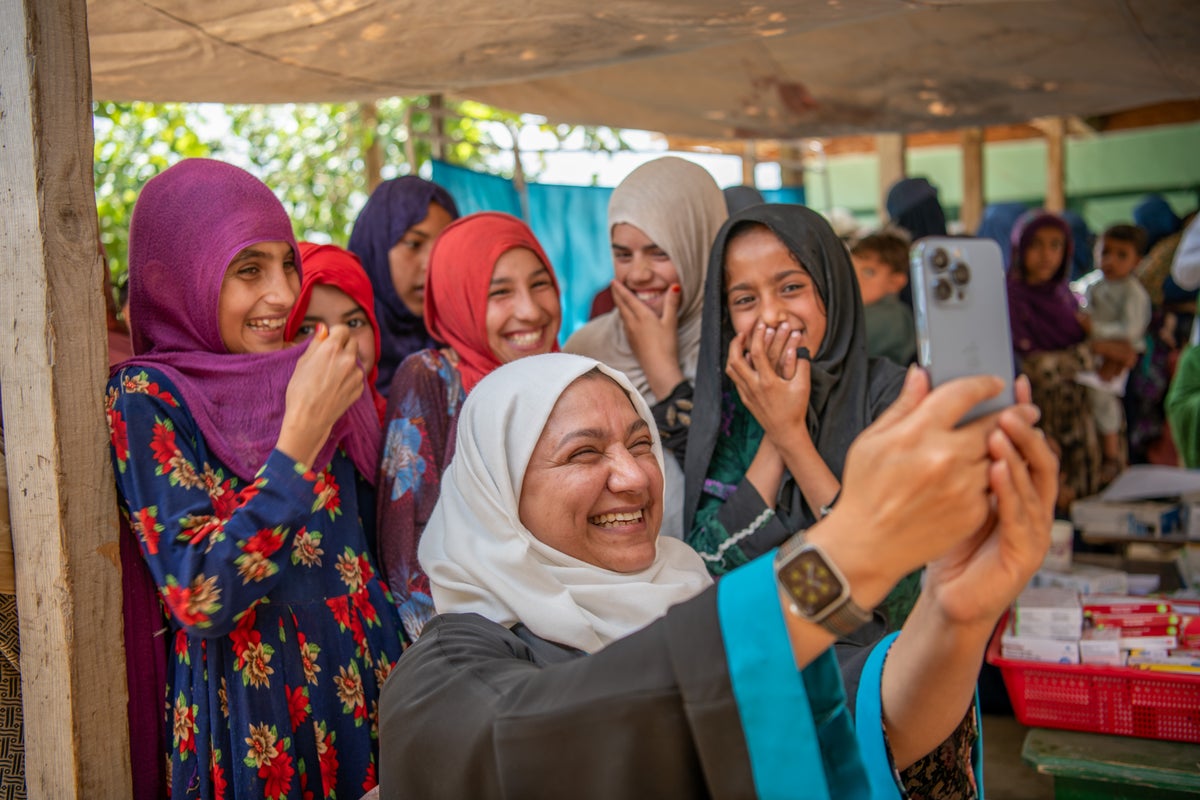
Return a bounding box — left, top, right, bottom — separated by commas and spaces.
106, 367, 321, 637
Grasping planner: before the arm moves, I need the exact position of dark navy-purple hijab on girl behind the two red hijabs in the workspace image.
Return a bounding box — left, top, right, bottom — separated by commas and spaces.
349, 175, 458, 396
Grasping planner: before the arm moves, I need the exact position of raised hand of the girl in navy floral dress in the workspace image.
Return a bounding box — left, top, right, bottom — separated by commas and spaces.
276, 323, 364, 467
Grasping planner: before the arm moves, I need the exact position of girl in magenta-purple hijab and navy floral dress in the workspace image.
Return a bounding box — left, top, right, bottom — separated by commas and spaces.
106, 158, 403, 800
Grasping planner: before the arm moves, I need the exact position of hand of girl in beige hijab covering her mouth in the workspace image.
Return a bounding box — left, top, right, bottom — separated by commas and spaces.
612, 281, 684, 399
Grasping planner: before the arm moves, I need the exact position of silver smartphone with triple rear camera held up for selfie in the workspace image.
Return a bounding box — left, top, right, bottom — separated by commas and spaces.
910, 236, 1016, 425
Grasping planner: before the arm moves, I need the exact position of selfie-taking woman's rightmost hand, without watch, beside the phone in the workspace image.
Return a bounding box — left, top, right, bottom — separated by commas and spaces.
925, 378, 1058, 630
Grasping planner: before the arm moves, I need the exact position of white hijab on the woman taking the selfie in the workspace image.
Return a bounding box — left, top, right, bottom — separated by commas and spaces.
418, 353, 712, 652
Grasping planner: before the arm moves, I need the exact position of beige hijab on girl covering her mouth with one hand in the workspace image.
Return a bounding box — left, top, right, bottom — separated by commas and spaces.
564, 156, 730, 403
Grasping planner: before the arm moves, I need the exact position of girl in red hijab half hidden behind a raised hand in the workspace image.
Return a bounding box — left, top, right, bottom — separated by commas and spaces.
284, 241, 388, 420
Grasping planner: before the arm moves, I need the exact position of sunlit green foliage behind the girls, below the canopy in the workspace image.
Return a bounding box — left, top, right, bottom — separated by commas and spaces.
92, 96, 629, 297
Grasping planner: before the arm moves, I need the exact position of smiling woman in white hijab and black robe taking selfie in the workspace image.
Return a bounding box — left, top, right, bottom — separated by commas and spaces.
380, 354, 1056, 799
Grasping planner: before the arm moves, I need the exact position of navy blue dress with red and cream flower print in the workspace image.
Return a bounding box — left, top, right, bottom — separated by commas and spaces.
106, 366, 403, 800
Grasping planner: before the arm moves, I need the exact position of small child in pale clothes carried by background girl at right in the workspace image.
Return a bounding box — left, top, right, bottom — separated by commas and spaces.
1074, 225, 1151, 482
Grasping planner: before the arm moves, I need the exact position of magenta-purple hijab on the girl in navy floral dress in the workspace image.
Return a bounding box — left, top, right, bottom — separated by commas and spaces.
121, 158, 382, 483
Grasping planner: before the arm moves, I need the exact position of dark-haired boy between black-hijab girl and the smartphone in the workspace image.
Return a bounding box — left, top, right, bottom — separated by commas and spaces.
850, 229, 917, 367
